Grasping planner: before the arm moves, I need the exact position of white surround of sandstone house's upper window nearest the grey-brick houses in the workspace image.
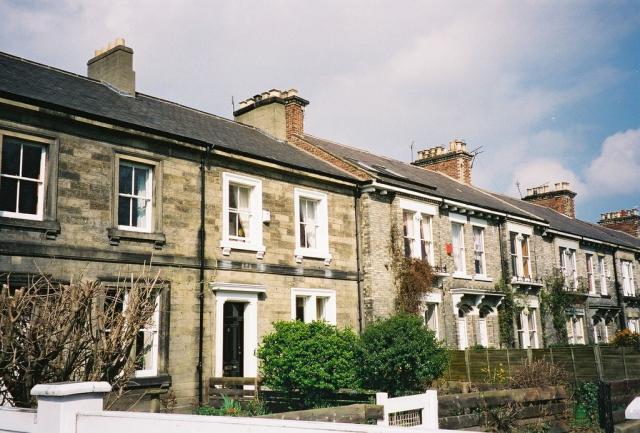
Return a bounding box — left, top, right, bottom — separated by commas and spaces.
293, 188, 331, 265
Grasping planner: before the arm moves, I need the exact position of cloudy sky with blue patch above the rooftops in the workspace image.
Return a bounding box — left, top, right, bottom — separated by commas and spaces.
0, 0, 640, 221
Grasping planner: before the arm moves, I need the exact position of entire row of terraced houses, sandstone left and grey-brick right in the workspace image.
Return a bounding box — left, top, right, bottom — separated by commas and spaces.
0, 41, 640, 408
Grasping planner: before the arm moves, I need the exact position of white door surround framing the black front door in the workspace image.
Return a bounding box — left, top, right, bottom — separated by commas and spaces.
211, 283, 266, 377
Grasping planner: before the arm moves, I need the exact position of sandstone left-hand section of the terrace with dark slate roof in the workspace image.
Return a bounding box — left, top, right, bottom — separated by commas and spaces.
0, 41, 358, 408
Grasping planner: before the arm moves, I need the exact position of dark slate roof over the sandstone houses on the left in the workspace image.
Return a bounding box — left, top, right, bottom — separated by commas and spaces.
0, 52, 355, 180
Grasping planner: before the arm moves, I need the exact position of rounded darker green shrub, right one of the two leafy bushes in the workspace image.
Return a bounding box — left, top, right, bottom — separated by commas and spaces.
358, 314, 448, 395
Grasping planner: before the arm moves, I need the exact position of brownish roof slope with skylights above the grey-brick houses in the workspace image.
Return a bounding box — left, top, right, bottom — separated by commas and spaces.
305, 135, 542, 220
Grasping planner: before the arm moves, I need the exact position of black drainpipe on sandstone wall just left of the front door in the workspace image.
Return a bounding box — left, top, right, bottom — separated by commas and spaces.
196, 145, 213, 406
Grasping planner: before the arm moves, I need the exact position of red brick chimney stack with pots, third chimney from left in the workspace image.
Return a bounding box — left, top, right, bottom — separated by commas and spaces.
412, 140, 473, 185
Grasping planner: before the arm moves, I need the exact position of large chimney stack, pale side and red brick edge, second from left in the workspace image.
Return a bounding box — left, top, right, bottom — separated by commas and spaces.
233, 89, 309, 141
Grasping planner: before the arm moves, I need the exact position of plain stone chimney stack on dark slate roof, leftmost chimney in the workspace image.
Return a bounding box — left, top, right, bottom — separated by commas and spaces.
87, 38, 136, 96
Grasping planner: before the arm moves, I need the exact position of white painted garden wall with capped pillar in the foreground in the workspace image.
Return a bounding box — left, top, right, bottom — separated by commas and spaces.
0, 382, 462, 433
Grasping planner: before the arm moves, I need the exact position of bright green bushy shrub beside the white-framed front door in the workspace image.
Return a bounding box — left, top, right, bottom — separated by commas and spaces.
258, 321, 359, 407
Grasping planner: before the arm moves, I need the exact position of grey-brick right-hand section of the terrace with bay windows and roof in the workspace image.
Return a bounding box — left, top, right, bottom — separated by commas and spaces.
235, 86, 640, 349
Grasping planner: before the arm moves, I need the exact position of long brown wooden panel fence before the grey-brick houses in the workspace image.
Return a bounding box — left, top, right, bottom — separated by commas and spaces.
444, 346, 640, 382
